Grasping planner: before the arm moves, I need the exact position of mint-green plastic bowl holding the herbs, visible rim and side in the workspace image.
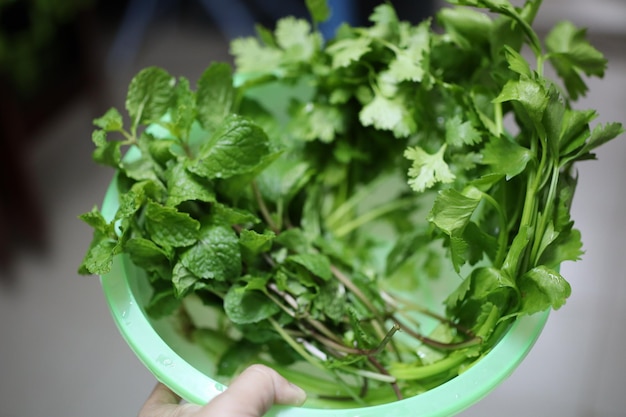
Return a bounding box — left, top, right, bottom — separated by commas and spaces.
101, 171, 548, 417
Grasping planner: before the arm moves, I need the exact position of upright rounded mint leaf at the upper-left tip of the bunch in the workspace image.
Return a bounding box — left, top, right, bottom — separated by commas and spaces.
126, 67, 176, 130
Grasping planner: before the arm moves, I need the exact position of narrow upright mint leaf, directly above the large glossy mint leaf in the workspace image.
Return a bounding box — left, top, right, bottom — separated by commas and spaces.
196, 63, 235, 131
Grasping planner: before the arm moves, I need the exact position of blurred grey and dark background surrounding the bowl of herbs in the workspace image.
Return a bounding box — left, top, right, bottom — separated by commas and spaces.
0, 0, 626, 417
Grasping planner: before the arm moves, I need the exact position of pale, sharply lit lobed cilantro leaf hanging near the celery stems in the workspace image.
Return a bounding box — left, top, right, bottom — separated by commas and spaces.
404, 144, 455, 192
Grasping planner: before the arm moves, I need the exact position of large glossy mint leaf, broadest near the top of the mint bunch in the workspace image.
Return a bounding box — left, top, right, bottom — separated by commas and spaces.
188, 115, 269, 179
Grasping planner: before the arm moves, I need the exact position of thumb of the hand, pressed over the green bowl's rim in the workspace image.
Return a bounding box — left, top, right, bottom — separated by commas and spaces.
199, 365, 306, 417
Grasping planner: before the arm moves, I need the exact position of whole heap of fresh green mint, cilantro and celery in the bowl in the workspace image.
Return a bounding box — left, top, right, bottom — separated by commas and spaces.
80, 0, 623, 404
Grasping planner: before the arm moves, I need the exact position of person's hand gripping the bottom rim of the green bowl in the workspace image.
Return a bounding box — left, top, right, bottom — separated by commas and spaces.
139, 365, 306, 417
